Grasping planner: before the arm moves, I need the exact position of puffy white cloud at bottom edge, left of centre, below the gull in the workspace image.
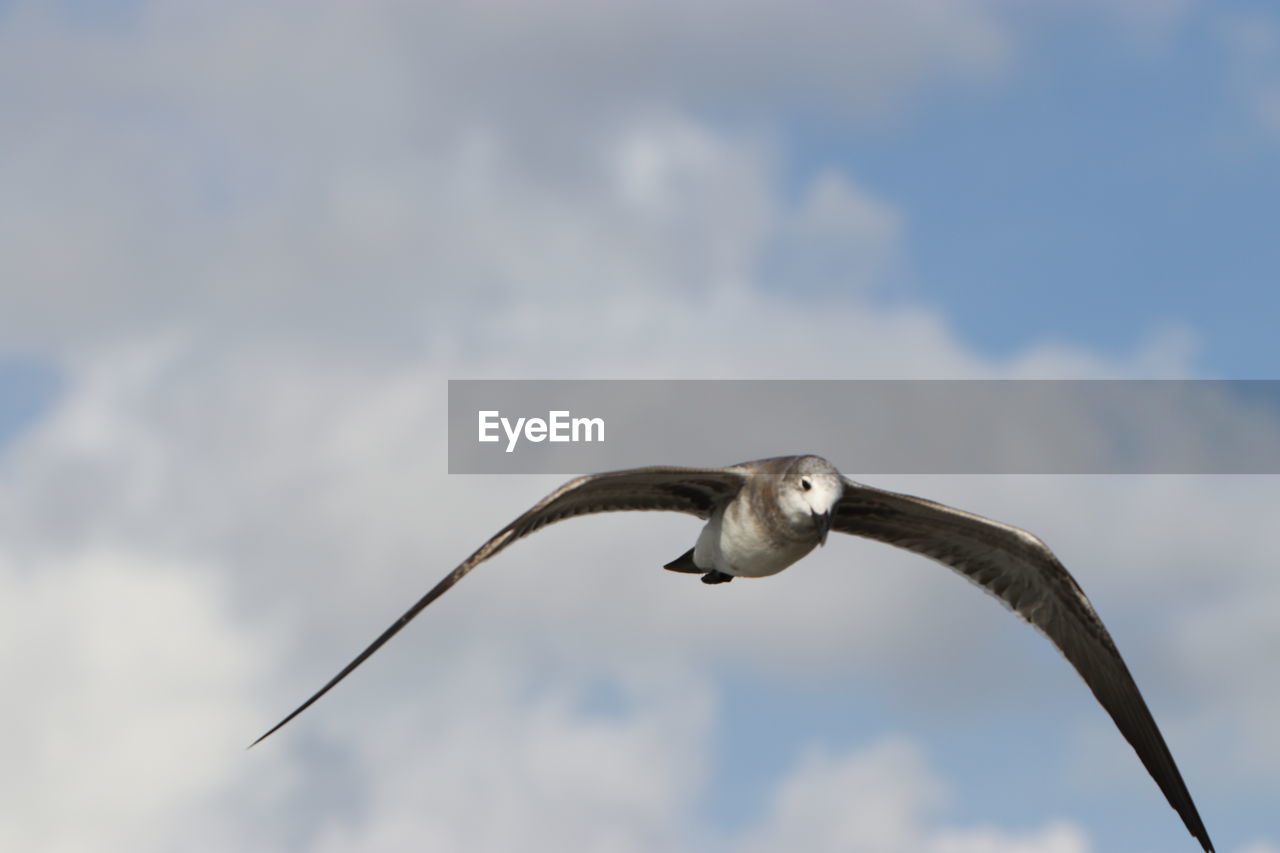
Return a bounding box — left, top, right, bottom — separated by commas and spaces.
302, 666, 712, 852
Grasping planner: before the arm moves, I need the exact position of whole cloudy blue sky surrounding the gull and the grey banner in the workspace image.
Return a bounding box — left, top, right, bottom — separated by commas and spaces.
0, 0, 1280, 853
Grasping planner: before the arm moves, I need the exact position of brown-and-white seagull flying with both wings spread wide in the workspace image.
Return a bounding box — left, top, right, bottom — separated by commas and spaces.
250, 456, 1213, 853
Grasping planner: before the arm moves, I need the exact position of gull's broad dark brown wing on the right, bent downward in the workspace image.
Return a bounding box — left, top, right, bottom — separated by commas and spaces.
831, 478, 1213, 853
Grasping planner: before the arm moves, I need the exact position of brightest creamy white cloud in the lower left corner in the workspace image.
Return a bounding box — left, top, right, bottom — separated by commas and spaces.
0, 548, 270, 850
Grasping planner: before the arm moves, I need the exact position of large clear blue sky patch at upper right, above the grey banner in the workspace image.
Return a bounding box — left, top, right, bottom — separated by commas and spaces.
796, 4, 1280, 378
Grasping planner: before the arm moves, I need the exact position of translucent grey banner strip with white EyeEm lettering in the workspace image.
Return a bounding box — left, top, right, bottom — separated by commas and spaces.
449, 379, 1280, 476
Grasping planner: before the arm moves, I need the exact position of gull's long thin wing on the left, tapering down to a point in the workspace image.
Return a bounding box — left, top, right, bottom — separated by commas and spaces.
250, 466, 746, 747
